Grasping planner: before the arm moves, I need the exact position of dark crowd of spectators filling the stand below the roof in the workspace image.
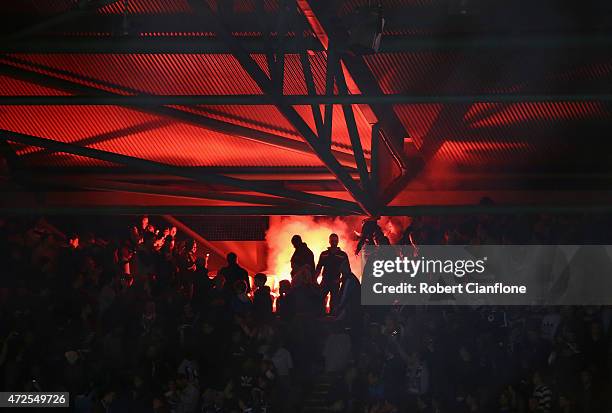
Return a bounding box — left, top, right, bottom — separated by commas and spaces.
0, 215, 612, 413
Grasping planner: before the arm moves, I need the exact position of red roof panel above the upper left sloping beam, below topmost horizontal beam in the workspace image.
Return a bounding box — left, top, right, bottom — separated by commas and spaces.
0, 55, 371, 159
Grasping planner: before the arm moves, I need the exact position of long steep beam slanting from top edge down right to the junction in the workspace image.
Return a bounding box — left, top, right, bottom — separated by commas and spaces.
190, 0, 373, 214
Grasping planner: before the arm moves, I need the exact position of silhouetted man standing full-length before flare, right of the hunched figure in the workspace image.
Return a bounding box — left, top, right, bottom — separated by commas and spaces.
314, 234, 350, 309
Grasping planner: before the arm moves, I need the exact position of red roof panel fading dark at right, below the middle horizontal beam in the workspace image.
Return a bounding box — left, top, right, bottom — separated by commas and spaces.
394, 102, 612, 165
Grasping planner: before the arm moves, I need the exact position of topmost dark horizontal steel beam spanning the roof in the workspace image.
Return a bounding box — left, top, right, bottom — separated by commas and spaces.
0, 35, 612, 54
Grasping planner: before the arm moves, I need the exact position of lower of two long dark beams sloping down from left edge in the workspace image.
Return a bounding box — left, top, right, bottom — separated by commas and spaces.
0, 129, 360, 212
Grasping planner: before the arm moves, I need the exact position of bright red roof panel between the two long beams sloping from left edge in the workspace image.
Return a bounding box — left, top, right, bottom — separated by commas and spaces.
0, 106, 323, 167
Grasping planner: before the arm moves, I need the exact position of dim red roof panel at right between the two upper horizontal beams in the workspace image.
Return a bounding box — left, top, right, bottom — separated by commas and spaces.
364, 51, 612, 95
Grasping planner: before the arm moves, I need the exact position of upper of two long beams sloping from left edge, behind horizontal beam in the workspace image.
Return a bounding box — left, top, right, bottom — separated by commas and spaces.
0, 57, 355, 166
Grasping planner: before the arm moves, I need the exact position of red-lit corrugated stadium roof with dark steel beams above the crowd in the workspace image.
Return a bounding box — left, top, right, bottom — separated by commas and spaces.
0, 0, 612, 215
